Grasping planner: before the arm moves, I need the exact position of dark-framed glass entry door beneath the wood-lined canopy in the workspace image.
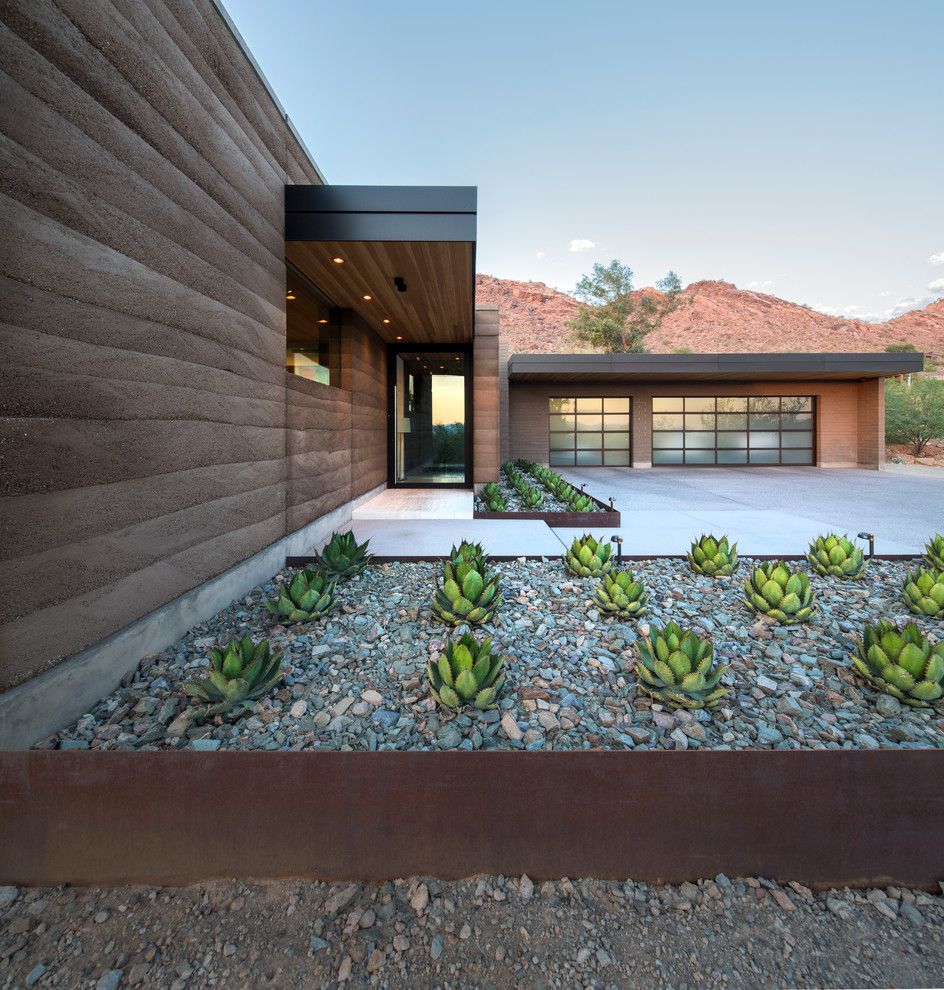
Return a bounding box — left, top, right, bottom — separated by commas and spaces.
389, 349, 470, 487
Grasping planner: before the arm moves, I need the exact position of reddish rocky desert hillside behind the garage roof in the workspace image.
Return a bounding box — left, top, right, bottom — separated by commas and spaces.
476, 275, 944, 360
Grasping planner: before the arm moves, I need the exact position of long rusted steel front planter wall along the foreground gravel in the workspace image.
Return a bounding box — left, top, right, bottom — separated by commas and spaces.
0, 750, 944, 888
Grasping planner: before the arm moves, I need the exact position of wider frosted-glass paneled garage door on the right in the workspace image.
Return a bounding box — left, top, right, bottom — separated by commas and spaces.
652, 395, 815, 465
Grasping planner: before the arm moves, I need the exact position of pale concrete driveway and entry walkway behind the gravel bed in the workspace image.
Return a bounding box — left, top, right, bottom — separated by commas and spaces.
314, 467, 928, 557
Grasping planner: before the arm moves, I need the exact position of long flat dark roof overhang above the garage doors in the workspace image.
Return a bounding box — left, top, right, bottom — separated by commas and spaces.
508, 353, 924, 382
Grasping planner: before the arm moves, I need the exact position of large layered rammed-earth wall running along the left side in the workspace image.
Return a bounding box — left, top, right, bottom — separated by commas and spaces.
0, 0, 385, 689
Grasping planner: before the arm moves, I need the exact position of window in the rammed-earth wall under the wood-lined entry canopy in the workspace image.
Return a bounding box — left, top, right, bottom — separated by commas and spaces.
285, 264, 341, 387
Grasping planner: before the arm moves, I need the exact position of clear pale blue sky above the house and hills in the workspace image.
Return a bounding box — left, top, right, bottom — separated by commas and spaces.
226, 0, 944, 319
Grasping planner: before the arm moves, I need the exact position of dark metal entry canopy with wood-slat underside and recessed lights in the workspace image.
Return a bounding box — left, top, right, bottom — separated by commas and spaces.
285, 186, 477, 343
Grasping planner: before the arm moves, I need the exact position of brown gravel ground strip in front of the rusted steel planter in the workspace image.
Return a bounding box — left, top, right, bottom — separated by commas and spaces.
0, 875, 944, 990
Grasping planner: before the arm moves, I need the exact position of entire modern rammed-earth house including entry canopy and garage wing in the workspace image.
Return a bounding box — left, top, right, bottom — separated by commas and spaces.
0, 0, 921, 744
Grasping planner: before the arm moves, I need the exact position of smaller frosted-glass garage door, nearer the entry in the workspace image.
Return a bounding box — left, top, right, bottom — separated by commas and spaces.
548, 396, 632, 467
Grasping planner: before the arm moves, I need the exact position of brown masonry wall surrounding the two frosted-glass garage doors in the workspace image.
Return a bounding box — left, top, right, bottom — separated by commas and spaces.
509, 381, 884, 468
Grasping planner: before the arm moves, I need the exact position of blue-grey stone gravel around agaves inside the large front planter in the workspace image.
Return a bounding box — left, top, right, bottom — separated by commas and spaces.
48, 559, 944, 750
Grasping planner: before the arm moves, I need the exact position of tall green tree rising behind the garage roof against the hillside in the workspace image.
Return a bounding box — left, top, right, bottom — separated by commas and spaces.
567, 258, 691, 354
